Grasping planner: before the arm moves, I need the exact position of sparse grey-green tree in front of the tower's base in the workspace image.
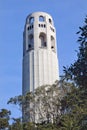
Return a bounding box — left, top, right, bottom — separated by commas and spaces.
8, 80, 71, 129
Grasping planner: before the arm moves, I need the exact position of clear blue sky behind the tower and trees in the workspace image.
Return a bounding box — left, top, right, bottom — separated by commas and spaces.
0, 0, 87, 116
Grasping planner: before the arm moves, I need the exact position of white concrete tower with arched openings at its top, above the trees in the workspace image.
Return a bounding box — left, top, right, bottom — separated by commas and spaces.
22, 12, 59, 95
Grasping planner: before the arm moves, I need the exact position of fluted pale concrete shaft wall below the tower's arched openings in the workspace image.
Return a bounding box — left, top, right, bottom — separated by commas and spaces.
23, 49, 58, 94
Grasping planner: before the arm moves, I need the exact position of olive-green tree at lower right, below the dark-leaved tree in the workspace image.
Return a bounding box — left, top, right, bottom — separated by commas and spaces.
60, 87, 87, 130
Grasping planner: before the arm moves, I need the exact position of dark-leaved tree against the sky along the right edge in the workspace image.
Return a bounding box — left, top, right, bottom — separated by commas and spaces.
64, 17, 87, 88
